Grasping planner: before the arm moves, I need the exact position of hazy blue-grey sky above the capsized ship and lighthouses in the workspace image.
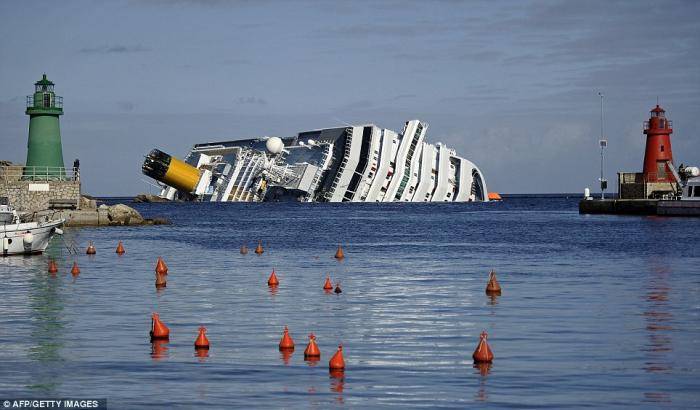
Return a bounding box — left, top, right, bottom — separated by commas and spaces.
0, 0, 700, 195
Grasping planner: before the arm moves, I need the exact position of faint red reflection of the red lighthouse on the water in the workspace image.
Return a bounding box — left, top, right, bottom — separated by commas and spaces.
644, 260, 673, 402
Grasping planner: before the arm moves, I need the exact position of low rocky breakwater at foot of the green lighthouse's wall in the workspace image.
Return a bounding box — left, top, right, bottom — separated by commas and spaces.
32, 204, 170, 227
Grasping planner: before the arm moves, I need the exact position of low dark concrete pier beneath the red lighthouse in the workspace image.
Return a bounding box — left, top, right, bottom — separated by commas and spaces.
578, 199, 700, 216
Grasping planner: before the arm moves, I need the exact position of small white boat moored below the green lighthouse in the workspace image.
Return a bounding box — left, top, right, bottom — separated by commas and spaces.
0, 205, 65, 256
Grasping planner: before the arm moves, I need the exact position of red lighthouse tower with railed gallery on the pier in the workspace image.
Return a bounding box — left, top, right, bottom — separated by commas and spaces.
644, 104, 676, 183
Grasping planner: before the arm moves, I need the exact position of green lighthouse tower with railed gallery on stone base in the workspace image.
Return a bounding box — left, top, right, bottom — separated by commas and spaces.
24, 74, 66, 179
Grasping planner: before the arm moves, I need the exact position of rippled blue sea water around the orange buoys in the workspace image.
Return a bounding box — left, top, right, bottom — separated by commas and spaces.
0, 198, 700, 409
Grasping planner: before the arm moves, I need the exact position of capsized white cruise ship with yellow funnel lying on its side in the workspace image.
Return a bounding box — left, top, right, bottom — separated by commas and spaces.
142, 120, 488, 202
